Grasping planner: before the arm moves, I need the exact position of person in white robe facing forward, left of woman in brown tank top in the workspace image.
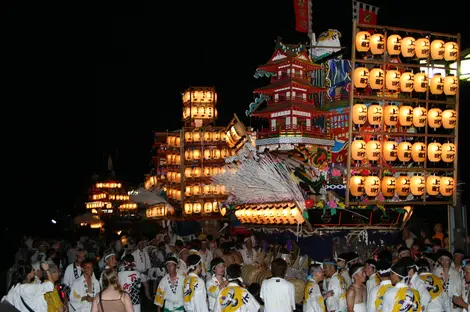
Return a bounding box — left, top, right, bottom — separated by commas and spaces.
69, 260, 101, 312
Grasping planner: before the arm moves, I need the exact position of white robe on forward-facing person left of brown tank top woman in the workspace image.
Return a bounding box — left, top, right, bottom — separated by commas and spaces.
69, 274, 101, 312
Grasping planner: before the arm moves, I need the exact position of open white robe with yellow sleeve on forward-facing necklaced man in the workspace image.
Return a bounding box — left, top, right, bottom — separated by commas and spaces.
154, 273, 184, 312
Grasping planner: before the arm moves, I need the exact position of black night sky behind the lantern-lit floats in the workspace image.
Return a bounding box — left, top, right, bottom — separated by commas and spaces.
1, 0, 470, 225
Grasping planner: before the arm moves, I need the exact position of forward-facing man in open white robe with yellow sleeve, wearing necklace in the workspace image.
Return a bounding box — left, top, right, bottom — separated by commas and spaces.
154, 257, 184, 312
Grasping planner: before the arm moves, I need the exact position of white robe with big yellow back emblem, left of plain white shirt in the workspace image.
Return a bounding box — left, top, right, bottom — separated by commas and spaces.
213, 282, 260, 312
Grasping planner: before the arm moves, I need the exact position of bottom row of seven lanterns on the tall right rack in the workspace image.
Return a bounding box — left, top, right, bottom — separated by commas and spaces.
349, 175, 455, 197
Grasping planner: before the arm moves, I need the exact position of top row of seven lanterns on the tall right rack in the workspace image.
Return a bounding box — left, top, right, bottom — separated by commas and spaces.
356, 31, 459, 61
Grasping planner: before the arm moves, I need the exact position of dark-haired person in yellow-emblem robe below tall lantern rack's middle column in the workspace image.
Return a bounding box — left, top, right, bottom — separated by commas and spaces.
382, 263, 422, 312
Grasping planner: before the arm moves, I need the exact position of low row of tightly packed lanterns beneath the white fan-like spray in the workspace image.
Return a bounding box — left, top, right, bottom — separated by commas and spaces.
235, 203, 305, 225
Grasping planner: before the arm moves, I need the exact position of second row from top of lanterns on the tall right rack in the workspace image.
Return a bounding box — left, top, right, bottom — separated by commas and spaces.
354, 67, 458, 95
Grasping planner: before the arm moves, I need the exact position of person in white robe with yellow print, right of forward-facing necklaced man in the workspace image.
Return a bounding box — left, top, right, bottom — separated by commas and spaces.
183, 255, 209, 312
